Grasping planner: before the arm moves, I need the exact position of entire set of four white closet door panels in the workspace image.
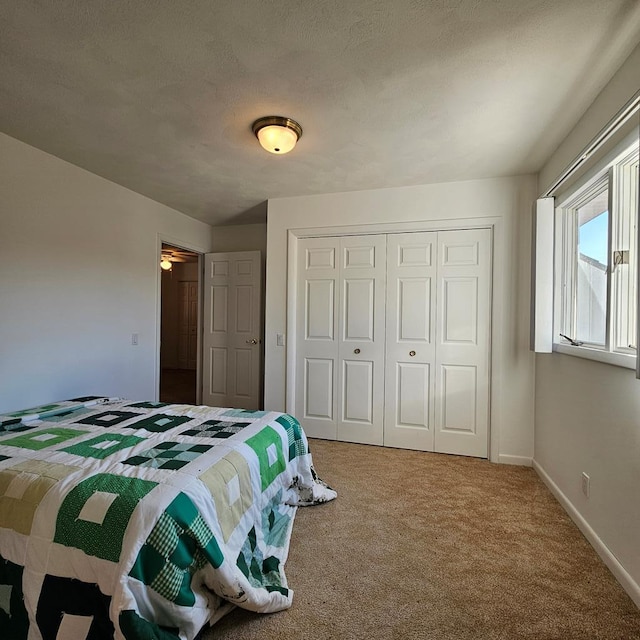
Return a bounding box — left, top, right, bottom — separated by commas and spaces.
295, 229, 491, 457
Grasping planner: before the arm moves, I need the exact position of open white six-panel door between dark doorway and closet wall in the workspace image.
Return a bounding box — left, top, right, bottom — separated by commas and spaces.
202, 251, 262, 409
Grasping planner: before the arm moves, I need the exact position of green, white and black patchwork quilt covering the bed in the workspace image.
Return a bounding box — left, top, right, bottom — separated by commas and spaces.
0, 397, 336, 640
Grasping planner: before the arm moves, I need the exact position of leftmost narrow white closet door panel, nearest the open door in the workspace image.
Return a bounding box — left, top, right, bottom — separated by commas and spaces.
295, 238, 340, 440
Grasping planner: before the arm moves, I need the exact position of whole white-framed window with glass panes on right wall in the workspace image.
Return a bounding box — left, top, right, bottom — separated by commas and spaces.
554, 143, 638, 367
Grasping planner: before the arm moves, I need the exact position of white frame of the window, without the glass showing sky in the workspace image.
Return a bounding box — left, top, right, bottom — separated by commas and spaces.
553, 140, 640, 369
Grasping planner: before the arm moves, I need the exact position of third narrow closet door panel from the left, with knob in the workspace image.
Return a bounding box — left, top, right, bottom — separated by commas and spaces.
384, 232, 437, 451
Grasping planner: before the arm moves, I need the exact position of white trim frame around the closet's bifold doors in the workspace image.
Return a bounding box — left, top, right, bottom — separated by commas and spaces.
285, 217, 507, 462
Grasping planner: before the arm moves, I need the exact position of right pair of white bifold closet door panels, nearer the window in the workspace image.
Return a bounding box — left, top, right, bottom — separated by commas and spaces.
384, 229, 491, 458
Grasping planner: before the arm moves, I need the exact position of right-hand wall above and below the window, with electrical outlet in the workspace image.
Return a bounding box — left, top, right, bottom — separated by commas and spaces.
535, 47, 640, 606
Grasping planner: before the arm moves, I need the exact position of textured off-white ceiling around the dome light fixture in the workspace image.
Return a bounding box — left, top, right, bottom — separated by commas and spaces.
0, 0, 640, 224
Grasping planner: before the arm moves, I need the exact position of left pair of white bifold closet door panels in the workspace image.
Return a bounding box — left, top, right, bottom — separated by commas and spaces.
295, 235, 386, 444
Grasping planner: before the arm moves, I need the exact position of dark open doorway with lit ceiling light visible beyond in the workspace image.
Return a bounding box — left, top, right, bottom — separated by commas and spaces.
159, 243, 200, 404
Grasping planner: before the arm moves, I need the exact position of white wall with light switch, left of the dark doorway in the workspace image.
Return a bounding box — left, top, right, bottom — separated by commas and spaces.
0, 134, 211, 411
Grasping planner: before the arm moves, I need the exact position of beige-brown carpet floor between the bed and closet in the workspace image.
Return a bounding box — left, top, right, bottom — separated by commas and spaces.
201, 440, 640, 640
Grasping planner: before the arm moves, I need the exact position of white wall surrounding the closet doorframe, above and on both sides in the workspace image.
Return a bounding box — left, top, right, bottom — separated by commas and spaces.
265, 176, 535, 464
